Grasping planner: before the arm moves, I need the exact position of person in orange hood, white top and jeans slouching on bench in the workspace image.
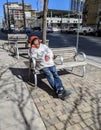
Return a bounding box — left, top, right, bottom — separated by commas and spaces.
30, 36, 71, 99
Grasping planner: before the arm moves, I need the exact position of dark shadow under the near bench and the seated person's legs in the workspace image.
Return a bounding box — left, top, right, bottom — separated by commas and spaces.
9, 67, 70, 98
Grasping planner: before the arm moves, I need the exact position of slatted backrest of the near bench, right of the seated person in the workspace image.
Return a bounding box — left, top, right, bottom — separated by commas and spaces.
51, 47, 77, 62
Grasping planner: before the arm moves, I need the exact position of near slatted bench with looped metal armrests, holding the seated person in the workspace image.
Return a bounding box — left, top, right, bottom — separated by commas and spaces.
28, 47, 87, 86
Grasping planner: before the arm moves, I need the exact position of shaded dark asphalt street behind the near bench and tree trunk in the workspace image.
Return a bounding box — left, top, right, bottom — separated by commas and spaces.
28, 32, 101, 64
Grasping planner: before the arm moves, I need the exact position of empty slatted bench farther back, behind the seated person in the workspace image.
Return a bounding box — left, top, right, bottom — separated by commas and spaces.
8, 34, 28, 59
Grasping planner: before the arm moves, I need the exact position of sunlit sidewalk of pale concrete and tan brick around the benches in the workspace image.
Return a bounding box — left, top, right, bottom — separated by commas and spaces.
0, 39, 101, 130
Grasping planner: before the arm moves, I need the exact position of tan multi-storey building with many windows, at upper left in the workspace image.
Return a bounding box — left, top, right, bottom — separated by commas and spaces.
3, 2, 36, 27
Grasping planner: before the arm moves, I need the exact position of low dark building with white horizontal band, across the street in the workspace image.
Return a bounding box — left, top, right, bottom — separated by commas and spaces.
34, 9, 82, 28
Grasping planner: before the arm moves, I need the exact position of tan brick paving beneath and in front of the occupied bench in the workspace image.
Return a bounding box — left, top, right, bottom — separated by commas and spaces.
0, 38, 101, 130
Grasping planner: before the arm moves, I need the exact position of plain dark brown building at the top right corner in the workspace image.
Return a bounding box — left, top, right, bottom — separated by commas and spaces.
83, 0, 101, 27
